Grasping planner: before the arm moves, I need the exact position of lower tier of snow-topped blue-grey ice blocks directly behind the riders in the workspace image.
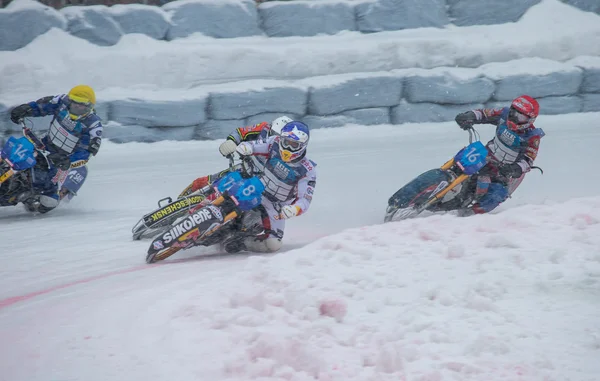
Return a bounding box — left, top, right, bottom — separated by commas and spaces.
0, 57, 600, 141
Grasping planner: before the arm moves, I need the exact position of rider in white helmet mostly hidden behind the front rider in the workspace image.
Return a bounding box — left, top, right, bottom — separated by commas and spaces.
179, 115, 292, 197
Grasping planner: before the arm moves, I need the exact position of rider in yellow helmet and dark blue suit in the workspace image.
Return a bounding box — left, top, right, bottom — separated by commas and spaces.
10, 85, 102, 213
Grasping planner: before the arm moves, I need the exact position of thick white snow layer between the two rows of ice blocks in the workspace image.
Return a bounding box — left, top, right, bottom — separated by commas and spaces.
0, 0, 600, 93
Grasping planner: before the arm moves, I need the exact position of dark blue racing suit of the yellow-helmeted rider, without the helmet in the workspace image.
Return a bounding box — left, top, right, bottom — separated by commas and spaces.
11, 94, 102, 213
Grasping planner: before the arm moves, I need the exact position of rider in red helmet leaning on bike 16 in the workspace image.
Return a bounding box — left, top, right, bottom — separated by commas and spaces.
455, 95, 545, 215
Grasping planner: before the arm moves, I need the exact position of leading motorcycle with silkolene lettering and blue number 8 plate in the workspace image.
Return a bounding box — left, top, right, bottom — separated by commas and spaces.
146, 158, 265, 263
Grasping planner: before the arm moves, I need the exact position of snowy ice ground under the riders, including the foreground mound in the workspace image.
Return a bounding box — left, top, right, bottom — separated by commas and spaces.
0, 113, 600, 381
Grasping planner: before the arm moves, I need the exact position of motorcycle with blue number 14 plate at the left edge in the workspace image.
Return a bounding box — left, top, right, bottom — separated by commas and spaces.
0, 122, 87, 211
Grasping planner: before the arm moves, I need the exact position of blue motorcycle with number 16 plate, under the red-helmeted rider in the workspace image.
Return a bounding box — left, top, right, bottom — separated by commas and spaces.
384, 128, 520, 222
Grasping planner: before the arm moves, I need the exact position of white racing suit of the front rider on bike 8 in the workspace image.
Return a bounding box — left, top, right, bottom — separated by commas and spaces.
232, 136, 317, 252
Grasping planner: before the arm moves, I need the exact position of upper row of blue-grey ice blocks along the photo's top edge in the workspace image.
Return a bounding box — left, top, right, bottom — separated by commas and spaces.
0, 0, 600, 50
